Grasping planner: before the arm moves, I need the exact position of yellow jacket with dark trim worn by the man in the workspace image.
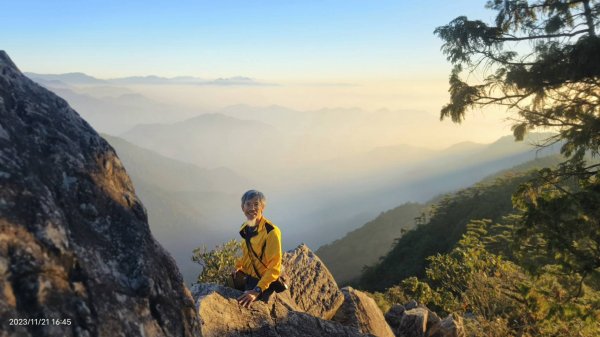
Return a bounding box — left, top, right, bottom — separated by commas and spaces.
235, 217, 281, 291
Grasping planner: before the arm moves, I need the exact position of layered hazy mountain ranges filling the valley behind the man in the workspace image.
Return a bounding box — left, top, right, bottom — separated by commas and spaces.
24, 73, 558, 281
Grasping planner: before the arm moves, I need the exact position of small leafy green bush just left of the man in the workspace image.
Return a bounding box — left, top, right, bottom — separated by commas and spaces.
192, 240, 242, 284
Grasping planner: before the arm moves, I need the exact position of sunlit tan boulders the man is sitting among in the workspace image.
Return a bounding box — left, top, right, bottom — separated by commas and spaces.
192, 245, 394, 337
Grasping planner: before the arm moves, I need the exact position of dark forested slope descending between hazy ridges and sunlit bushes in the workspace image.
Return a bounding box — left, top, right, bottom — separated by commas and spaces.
358, 155, 560, 290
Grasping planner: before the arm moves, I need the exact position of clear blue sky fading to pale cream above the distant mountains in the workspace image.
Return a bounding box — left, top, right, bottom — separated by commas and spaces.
0, 0, 492, 82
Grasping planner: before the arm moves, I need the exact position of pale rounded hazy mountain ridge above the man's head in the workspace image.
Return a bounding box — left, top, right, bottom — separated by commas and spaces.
121, 113, 285, 169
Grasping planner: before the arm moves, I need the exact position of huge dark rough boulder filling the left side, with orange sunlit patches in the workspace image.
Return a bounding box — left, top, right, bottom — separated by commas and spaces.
0, 51, 200, 337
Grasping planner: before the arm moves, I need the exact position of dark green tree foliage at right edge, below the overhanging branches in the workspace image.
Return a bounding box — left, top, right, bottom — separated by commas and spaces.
514, 170, 600, 277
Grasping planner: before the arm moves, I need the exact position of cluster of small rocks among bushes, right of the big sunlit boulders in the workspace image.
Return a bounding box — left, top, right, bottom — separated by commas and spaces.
385, 301, 465, 337
